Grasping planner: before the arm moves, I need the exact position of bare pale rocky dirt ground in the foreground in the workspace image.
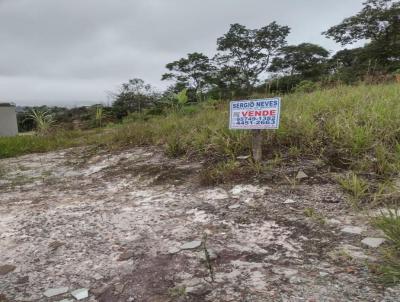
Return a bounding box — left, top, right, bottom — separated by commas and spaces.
0, 148, 400, 302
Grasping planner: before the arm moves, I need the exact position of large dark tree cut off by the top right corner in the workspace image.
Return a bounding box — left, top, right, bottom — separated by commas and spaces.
324, 0, 400, 69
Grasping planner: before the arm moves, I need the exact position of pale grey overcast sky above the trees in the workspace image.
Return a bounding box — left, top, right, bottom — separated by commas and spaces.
0, 0, 364, 106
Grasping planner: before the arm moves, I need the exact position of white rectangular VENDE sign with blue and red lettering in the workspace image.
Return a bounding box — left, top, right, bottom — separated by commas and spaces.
229, 98, 281, 129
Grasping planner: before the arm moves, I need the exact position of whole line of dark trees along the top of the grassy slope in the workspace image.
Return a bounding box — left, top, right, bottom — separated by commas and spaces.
18, 0, 400, 130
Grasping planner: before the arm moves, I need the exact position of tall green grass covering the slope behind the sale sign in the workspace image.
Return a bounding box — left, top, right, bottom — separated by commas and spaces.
0, 84, 400, 177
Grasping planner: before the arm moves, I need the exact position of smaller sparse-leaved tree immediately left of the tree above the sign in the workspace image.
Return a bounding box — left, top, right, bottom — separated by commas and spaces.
162, 52, 215, 99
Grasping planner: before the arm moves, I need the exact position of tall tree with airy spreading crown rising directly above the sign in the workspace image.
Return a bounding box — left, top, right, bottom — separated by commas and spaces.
216, 22, 290, 93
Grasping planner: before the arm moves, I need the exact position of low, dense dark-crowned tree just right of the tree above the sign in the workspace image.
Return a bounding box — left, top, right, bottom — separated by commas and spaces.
269, 43, 329, 79
